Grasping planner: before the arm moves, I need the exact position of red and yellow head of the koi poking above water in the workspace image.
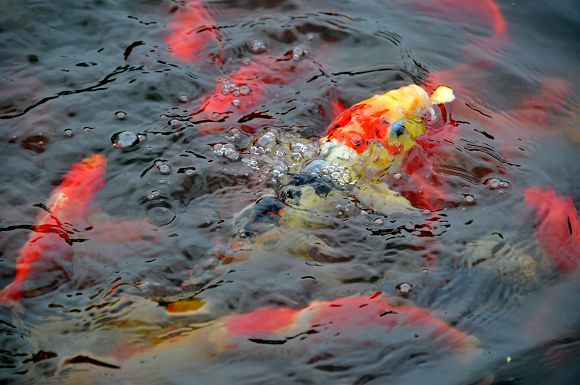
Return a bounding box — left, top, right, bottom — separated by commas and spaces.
321, 84, 455, 181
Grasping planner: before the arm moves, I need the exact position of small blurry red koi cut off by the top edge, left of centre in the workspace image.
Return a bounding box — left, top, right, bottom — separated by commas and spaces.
165, 0, 224, 63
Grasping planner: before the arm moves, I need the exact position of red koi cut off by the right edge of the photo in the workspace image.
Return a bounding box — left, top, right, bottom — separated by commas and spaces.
525, 187, 580, 273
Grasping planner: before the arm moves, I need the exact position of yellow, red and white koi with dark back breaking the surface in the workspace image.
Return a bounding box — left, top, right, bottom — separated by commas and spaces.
227, 85, 454, 261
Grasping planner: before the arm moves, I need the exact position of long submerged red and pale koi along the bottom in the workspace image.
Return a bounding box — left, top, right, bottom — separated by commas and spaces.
57, 293, 479, 380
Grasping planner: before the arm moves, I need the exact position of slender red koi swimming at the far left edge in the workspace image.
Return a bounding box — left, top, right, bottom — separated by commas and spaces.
0, 154, 107, 302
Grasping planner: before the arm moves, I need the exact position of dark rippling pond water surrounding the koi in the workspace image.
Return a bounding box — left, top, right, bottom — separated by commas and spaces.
0, 0, 580, 385
